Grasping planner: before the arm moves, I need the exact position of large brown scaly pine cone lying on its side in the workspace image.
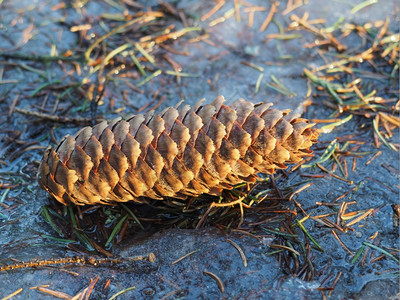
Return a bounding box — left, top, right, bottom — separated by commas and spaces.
38, 97, 318, 205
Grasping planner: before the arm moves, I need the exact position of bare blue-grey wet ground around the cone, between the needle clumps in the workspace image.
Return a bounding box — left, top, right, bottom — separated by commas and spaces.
0, 0, 399, 299
